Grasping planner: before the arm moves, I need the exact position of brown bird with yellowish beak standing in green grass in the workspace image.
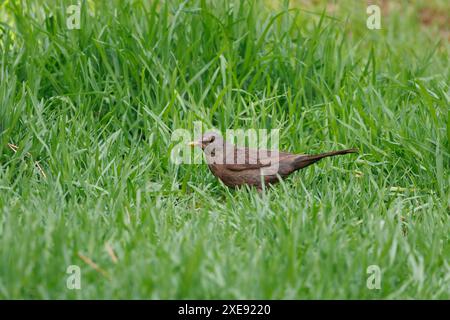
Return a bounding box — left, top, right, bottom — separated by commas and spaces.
189, 132, 358, 191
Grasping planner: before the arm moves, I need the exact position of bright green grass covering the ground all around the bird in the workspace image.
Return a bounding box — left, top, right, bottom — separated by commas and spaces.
0, 0, 450, 299
